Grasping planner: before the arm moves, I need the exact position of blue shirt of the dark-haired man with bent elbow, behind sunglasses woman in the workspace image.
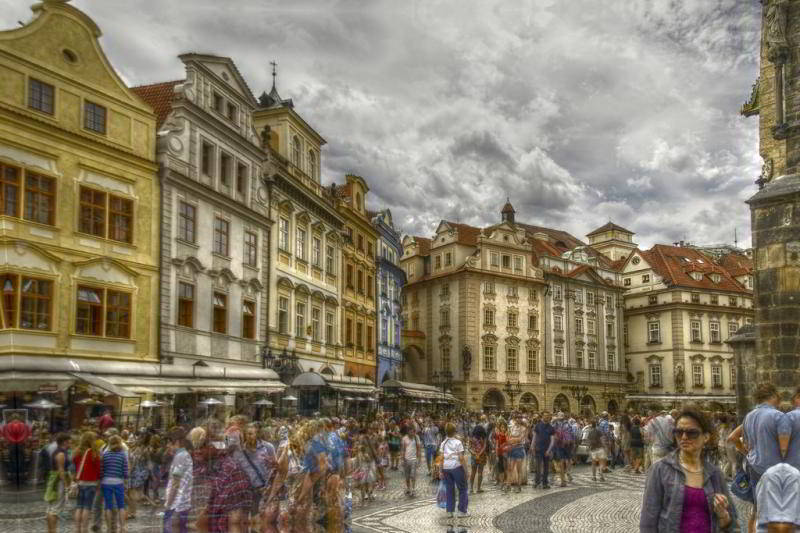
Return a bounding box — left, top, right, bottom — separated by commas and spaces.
742, 403, 792, 474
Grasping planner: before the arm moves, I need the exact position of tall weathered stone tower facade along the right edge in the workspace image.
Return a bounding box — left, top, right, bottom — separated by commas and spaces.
742, 0, 800, 400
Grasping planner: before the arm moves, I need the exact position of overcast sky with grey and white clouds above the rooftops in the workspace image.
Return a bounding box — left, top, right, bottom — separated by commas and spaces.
0, 0, 761, 247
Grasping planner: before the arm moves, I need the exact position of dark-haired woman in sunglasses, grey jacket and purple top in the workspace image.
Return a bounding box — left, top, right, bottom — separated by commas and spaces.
639, 408, 739, 533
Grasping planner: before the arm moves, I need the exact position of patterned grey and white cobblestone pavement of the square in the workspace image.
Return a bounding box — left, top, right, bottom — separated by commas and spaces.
0, 466, 749, 533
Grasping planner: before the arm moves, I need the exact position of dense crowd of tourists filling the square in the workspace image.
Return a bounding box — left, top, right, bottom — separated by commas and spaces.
3, 382, 800, 533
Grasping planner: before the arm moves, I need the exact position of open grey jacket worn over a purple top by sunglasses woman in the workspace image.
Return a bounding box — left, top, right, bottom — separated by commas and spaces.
639, 451, 739, 533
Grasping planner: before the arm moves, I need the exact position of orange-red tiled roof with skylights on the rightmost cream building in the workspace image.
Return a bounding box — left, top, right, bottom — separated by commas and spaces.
640, 244, 751, 294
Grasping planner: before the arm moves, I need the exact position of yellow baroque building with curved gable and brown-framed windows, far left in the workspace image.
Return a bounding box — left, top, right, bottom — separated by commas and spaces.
0, 0, 159, 418
